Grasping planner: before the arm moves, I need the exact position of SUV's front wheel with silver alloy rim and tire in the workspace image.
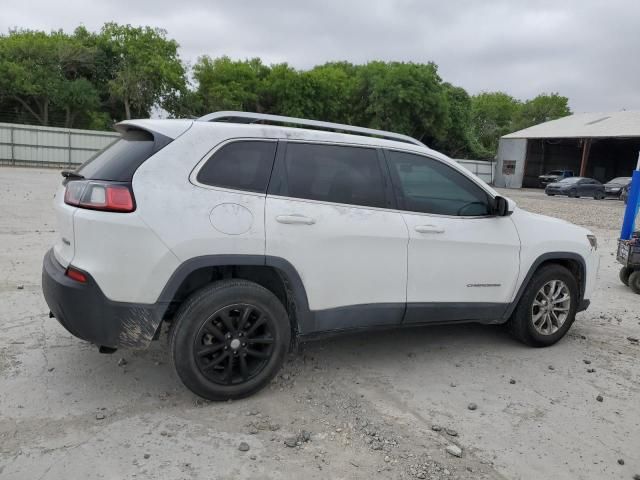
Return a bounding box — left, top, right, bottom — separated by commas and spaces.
508, 264, 579, 347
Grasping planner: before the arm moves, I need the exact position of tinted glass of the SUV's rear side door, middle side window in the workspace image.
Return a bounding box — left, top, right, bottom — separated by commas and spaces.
284, 143, 386, 207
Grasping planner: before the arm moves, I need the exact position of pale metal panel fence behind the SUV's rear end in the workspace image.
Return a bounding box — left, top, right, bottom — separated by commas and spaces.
0, 123, 119, 168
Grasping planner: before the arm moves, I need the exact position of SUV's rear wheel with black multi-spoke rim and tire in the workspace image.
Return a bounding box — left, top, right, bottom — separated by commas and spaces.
170, 280, 291, 400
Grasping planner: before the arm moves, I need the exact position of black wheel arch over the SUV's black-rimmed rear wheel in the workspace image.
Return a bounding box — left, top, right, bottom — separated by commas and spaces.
157, 254, 313, 339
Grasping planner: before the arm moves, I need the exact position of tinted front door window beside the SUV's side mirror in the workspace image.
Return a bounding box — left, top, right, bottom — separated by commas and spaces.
389, 151, 490, 216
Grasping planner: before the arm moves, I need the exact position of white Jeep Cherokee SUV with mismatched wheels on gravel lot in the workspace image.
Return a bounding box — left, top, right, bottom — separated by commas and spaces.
42, 112, 598, 400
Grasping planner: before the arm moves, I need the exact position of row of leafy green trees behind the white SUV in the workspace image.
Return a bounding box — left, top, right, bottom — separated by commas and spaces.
0, 23, 571, 158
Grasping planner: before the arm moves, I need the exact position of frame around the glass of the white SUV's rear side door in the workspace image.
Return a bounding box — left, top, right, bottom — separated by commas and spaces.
267, 139, 397, 212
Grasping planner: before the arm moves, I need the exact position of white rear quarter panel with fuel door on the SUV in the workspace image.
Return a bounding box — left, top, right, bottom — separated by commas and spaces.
133, 122, 272, 262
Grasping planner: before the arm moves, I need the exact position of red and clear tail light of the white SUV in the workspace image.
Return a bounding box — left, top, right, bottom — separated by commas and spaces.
64, 180, 136, 212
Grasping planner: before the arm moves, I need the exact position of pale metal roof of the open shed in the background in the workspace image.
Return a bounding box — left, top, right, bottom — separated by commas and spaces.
502, 110, 640, 138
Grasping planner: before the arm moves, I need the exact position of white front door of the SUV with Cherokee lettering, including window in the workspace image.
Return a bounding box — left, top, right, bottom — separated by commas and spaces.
387, 151, 520, 323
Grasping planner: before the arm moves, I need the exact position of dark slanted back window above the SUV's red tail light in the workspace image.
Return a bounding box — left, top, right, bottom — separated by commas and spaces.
77, 130, 170, 182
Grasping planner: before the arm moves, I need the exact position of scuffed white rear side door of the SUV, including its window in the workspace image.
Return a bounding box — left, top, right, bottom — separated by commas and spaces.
265, 142, 408, 333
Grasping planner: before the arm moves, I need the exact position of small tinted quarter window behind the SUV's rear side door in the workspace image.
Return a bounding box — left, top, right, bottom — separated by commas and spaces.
197, 141, 277, 193
